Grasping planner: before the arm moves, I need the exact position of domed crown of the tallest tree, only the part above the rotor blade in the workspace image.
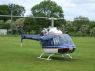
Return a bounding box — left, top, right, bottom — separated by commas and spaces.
31, 0, 64, 17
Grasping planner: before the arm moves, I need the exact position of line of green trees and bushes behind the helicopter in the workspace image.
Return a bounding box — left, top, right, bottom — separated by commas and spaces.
0, 0, 95, 36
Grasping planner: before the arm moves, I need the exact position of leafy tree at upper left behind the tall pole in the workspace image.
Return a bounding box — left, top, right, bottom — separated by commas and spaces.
0, 4, 25, 20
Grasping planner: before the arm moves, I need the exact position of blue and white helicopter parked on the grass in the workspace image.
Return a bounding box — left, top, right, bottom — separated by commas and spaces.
0, 15, 76, 60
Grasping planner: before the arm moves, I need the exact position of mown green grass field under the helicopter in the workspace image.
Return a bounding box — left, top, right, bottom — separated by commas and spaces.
0, 36, 95, 71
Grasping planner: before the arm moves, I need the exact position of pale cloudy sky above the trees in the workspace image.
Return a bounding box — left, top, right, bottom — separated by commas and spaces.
0, 0, 95, 20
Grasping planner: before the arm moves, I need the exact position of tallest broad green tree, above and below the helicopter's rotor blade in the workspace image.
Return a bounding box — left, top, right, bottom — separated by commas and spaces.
31, 0, 64, 28
